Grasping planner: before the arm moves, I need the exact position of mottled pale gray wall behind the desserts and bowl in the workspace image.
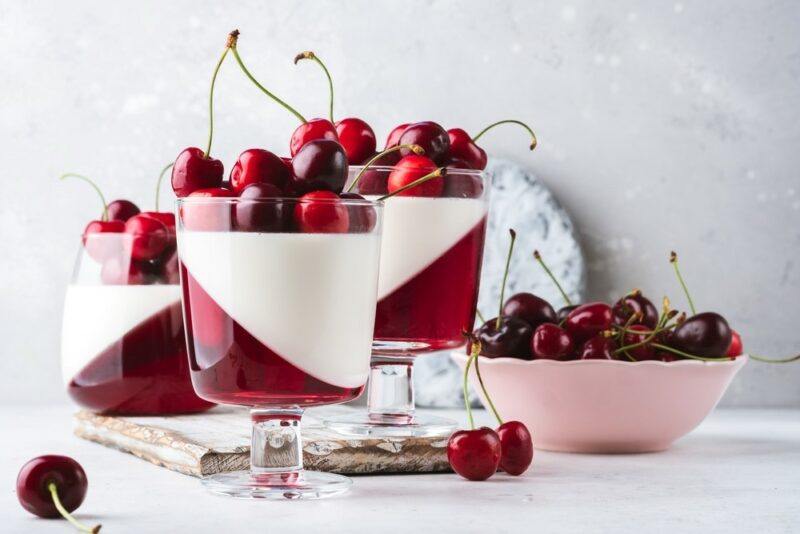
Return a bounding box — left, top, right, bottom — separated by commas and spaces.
0, 0, 800, 406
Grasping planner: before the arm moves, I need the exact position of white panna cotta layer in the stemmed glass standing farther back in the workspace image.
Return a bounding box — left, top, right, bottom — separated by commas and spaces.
378, 197, 488, 300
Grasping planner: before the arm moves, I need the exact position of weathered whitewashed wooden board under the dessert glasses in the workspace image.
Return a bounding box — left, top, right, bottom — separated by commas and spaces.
75, 406, 450, 477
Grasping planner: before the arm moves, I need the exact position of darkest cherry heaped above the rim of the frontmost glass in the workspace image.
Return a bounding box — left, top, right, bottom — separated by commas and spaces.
292, 139, 347, 194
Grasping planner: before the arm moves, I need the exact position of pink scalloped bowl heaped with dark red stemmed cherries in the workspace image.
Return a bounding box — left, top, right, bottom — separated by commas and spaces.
452, 230, 798, 453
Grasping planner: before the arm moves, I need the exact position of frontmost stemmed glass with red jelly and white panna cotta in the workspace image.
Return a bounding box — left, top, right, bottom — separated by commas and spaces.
178, 195, 383, 499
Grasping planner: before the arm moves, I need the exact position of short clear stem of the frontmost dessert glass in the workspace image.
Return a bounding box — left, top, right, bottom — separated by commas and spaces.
250, 406, 303, 474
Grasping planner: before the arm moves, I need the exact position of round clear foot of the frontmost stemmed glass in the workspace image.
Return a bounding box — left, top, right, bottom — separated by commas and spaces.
202, 471, 353, 500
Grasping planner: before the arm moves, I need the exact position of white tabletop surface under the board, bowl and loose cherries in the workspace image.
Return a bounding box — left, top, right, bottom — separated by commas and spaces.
0, 406, 800, 534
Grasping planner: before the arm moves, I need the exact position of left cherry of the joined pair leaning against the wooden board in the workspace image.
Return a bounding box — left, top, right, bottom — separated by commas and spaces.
447, 426, 502, 480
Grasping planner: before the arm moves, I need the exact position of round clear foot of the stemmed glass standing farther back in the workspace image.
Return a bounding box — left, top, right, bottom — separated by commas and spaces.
324, 413, 457, 438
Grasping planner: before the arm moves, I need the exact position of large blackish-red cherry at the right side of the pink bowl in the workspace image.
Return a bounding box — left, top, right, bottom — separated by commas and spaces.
669, 312, 733, 358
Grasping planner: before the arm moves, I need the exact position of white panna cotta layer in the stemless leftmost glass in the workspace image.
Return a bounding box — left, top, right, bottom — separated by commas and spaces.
61, 284, 181, 384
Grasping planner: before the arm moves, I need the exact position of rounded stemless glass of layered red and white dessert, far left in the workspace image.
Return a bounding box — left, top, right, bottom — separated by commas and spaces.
61, 232, 213, 415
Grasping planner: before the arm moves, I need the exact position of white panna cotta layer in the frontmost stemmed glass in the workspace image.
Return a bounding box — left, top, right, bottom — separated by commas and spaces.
178, 231, 380, 388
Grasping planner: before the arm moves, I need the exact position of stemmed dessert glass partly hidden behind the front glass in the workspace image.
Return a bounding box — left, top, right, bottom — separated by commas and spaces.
325, 167, 490, 437
